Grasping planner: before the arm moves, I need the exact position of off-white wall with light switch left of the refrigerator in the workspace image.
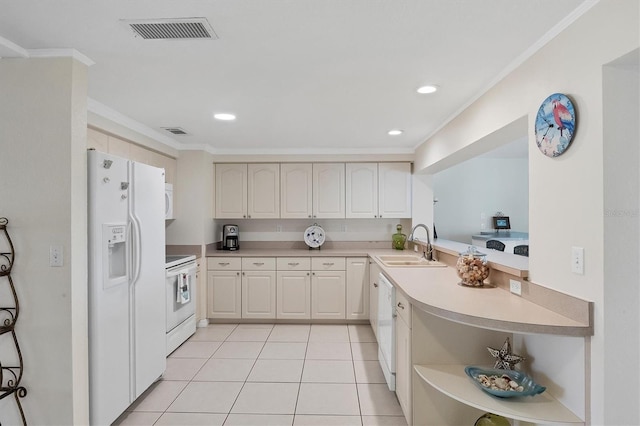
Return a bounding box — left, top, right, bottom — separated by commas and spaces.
0, 58, 89, 425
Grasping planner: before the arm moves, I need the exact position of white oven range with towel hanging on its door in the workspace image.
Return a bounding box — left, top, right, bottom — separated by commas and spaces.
165, 255, 197, 356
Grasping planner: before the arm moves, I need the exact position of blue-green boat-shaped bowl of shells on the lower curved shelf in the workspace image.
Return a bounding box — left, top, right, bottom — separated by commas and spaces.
464, 366, 547, 398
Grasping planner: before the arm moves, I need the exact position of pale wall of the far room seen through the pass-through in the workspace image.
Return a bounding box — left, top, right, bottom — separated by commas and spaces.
433, 158, 529, 244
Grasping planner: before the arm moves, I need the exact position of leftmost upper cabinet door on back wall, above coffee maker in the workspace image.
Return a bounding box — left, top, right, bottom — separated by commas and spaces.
215, 164, 247, 219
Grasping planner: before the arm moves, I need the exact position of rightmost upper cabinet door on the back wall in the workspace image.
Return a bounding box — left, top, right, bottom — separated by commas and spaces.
378, 163, 411, 219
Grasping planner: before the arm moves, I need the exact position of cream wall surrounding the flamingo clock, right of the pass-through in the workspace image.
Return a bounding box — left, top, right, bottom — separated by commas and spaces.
415, 0, 640, 424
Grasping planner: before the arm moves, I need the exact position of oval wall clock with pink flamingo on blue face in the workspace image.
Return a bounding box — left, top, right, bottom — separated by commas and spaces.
536, 93, 576, 157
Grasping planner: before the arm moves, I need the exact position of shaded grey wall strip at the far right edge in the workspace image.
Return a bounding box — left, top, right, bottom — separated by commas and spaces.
603, 51, 640, 425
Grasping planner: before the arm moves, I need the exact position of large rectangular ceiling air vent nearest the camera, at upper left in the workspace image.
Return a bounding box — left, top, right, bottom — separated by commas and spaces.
123, 18, 218, 40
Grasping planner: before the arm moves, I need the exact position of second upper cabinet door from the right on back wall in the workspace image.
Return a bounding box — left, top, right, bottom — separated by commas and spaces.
346, 163, 378, 219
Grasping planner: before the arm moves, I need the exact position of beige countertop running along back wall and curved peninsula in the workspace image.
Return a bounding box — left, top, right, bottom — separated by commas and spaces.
206, 240, 593, 336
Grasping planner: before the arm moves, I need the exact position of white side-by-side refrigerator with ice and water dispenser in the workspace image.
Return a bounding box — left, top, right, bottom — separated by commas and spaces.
88, 150, 166, 425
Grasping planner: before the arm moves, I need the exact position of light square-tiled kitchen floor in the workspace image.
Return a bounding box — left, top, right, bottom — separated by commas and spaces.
115, 324, 407, 426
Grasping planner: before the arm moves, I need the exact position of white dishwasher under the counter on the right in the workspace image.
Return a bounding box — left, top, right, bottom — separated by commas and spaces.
378, 274, 396, 391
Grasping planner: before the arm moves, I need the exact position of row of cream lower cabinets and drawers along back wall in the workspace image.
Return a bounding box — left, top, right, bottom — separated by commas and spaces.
207, 257, 364, 320
